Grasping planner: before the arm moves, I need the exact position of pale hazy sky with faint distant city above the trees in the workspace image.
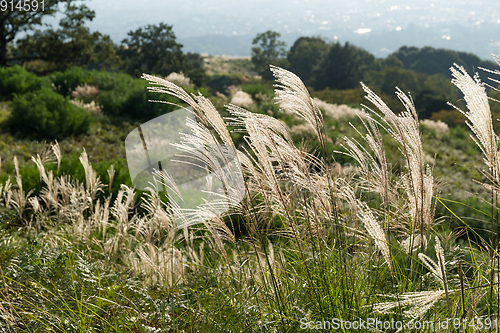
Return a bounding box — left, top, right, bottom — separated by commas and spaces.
44, 0, 500, 57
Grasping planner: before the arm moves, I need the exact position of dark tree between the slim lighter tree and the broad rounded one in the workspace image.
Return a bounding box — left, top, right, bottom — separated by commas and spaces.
287, 37, 329, 85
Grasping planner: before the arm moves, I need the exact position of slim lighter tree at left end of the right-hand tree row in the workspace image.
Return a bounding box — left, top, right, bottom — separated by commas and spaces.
252, 30, 288, 80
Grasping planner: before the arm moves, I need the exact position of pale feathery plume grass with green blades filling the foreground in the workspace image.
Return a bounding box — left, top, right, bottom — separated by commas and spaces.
0, 59, 500, 332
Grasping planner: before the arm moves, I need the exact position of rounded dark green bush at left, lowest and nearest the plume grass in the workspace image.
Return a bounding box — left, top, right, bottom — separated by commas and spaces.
9, 88, 92, 139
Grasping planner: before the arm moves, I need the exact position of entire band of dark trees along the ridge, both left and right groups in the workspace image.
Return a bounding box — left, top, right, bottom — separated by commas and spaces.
0, 0, 495, 118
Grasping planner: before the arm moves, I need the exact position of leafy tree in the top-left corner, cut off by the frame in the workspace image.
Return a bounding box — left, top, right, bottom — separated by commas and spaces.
0, 0, 71, 66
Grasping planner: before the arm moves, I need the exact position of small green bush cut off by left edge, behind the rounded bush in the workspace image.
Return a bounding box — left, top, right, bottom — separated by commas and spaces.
0, 65, 50, 101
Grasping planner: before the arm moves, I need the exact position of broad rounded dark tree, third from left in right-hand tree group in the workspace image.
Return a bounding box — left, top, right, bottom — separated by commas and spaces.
313, 42, 375, 90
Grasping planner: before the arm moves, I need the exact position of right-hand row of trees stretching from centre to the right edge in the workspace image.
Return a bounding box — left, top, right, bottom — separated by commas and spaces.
252, 31, 495, 118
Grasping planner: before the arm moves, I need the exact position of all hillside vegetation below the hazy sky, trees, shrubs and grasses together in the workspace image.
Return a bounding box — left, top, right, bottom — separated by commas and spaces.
0, 9, 500, 332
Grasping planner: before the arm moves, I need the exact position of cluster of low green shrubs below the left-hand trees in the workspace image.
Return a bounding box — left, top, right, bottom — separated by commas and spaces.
0, 66, 184, 139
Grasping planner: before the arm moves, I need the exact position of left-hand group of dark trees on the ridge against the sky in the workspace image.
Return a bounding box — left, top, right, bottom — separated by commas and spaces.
0, 0, 205, 86
